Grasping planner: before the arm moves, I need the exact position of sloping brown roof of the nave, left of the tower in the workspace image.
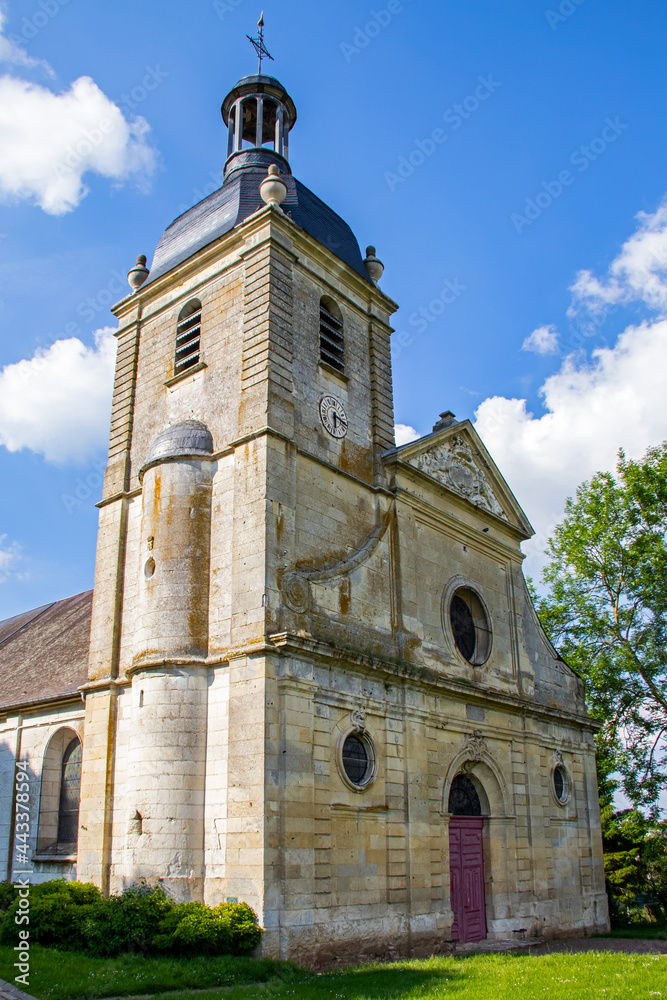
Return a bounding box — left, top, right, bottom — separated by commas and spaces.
0, 590, 93, 709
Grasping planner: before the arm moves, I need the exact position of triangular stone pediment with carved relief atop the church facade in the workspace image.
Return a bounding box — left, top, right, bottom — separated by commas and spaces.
385, 420, 534, 538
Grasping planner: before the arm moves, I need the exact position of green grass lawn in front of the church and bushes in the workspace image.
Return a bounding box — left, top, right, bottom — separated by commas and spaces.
0, 947, 667, 1000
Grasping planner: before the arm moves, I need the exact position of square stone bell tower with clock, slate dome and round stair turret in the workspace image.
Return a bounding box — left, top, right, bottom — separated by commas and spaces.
78, 47, 396, 920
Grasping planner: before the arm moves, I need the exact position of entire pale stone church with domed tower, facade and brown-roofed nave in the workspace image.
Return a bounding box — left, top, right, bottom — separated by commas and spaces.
0, 60, 608, 963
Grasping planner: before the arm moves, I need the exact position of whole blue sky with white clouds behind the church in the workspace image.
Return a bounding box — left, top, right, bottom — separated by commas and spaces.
0, 0, 667, 618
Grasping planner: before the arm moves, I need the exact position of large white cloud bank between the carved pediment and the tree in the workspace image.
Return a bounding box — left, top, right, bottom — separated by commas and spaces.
475, 202, 667, 576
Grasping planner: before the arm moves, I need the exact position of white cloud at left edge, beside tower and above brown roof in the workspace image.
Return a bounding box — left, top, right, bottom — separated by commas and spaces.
0, 327, 116, 464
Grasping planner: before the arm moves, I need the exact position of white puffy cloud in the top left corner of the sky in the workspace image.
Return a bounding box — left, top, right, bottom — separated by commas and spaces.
0, 14, 156, 215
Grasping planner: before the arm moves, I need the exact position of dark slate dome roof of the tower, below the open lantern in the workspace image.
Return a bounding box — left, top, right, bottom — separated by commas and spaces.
142, 165, 370, 290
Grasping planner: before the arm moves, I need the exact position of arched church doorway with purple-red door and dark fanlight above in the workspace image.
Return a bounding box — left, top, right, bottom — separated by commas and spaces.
448, 774, 486, 943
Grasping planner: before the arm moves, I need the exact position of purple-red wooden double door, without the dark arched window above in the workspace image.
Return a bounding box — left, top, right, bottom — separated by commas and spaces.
449, 816, 486, 942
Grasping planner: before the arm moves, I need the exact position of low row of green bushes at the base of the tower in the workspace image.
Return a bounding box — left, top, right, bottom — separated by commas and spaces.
0, 879, 263, 958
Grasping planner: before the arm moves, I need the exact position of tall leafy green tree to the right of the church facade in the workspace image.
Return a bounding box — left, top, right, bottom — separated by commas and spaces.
536, 442, 667, 818
